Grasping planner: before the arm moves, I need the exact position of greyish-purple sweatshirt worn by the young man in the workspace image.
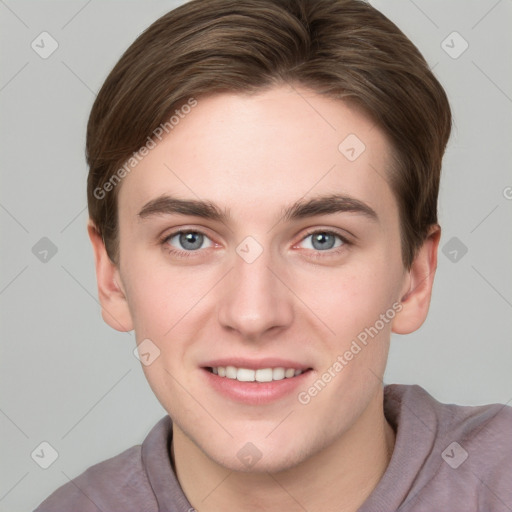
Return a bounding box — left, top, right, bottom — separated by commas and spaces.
35, 384, 512, 512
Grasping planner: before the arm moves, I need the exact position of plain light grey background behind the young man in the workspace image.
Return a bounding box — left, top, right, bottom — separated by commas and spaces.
0, 0, 512, 512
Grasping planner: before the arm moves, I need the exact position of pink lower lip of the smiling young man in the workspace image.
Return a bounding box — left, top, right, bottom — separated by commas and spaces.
202, 368, 311, 405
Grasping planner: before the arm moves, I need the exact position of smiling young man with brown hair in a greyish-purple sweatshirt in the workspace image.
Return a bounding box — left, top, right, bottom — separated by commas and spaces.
37, 0, 512, 512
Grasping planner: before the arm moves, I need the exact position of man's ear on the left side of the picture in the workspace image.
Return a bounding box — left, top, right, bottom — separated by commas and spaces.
87, 220, 133, 332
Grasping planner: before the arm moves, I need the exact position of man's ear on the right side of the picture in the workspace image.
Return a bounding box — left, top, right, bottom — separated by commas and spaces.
392, 224, 441, 334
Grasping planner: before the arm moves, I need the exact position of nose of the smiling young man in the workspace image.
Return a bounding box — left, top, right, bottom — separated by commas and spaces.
218, 244, 294, 341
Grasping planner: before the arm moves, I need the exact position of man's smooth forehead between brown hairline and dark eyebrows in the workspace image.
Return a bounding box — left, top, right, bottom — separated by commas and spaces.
119, 86, 396, 224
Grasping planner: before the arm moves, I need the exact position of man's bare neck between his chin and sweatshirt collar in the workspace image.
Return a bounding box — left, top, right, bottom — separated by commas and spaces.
171, 391, 395, 512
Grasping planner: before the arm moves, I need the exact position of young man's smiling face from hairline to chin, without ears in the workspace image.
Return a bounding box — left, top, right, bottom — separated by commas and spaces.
94, 87, 418, 471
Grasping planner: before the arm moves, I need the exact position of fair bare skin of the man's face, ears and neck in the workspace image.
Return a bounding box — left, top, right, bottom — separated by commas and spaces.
89, 86, 440, 512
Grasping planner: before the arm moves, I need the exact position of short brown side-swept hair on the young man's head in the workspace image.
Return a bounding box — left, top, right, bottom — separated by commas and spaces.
87, 0, 451, 267
